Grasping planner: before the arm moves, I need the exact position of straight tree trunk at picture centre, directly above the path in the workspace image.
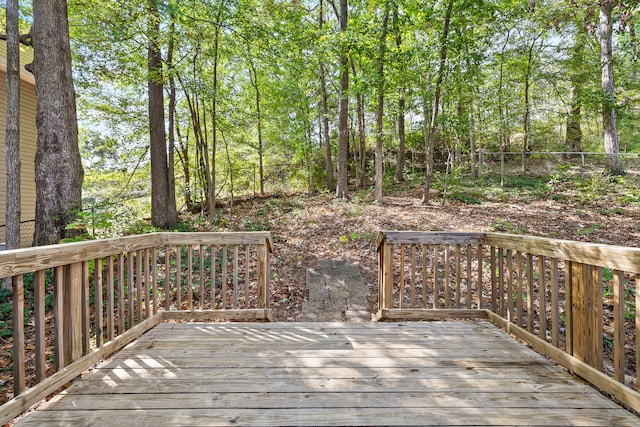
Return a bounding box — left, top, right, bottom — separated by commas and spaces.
336, 0, 349, 199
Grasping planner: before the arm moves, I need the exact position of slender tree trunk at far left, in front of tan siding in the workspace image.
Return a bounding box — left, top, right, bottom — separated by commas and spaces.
5, 0, 22, 251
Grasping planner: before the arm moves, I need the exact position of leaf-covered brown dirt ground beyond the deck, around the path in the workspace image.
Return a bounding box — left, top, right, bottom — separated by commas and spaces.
227, 180, 640, 321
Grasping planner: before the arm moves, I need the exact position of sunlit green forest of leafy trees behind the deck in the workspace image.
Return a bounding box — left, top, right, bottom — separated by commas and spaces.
1, 0, 640, 237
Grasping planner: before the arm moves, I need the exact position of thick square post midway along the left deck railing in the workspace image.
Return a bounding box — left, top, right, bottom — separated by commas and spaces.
61, 263, 83, 367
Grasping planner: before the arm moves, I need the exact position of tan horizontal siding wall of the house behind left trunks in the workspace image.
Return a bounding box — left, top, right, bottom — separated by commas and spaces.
0, 71, 36, 246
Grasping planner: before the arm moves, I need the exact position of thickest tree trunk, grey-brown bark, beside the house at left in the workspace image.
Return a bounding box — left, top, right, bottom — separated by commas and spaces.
32, 0, 84, 245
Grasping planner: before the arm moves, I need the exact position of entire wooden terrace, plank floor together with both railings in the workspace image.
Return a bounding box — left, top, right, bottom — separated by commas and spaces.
0, 232, 640, 426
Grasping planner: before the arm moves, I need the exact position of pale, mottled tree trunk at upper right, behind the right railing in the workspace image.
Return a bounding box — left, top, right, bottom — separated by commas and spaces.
600, 0, 624, 175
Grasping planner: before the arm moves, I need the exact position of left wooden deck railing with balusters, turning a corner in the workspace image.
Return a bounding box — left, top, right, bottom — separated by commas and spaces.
0, 232, 273, 424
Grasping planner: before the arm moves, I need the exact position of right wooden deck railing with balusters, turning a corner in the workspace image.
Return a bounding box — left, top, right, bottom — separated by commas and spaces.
377, 231, 640, 410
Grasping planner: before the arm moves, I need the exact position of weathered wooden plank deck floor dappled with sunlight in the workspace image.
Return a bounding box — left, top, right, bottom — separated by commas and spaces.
17, 322, 640, 427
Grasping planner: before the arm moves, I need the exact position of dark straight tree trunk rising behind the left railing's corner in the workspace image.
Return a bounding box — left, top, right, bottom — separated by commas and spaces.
147, 0, 178, 228
